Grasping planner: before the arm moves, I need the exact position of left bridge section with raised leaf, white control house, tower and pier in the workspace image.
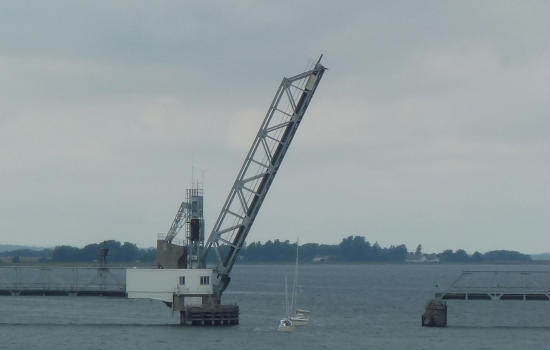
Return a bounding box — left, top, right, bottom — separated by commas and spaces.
0, 55, 326, 325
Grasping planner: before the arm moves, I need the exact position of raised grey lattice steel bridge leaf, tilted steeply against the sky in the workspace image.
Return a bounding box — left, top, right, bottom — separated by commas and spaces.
201, 58, 326, 298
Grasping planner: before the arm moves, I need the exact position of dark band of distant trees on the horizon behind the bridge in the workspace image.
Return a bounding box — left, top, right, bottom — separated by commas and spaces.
0, 236, 532, 263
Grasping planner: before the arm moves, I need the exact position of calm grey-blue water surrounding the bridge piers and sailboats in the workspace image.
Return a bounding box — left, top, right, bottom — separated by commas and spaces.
0, 265, 550, 349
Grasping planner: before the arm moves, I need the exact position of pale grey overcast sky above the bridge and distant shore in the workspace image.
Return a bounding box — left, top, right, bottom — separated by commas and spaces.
0, 0, 550, 253
